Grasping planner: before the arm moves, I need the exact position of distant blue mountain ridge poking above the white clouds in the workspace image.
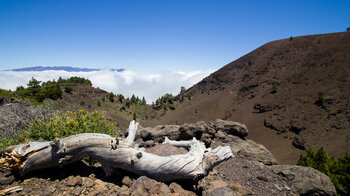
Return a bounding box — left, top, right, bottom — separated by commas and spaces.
6, 66, 125, 72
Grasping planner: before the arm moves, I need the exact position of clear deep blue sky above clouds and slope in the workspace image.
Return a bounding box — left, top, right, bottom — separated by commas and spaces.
0, 0, 350, 73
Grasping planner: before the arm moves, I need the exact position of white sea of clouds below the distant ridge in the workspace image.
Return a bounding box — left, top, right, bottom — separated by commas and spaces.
0, 70, 215, 103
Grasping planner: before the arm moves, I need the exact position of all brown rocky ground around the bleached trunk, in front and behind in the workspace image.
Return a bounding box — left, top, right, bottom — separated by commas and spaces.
1, 120, 336, 196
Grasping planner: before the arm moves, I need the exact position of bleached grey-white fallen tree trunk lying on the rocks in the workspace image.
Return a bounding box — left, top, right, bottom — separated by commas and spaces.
0, 121, 233, 181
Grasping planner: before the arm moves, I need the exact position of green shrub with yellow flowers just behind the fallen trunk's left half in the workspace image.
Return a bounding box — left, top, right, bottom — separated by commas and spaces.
0, 110, 117, 149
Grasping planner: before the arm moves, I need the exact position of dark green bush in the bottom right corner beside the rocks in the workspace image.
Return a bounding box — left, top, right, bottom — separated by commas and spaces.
297, 148, 350, 195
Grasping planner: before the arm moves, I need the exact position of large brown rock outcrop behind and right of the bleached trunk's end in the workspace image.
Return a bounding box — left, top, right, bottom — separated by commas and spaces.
137, 119, 336, 195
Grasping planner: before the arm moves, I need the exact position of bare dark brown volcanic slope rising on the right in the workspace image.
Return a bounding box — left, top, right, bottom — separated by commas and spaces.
155, 32, 350, 163
